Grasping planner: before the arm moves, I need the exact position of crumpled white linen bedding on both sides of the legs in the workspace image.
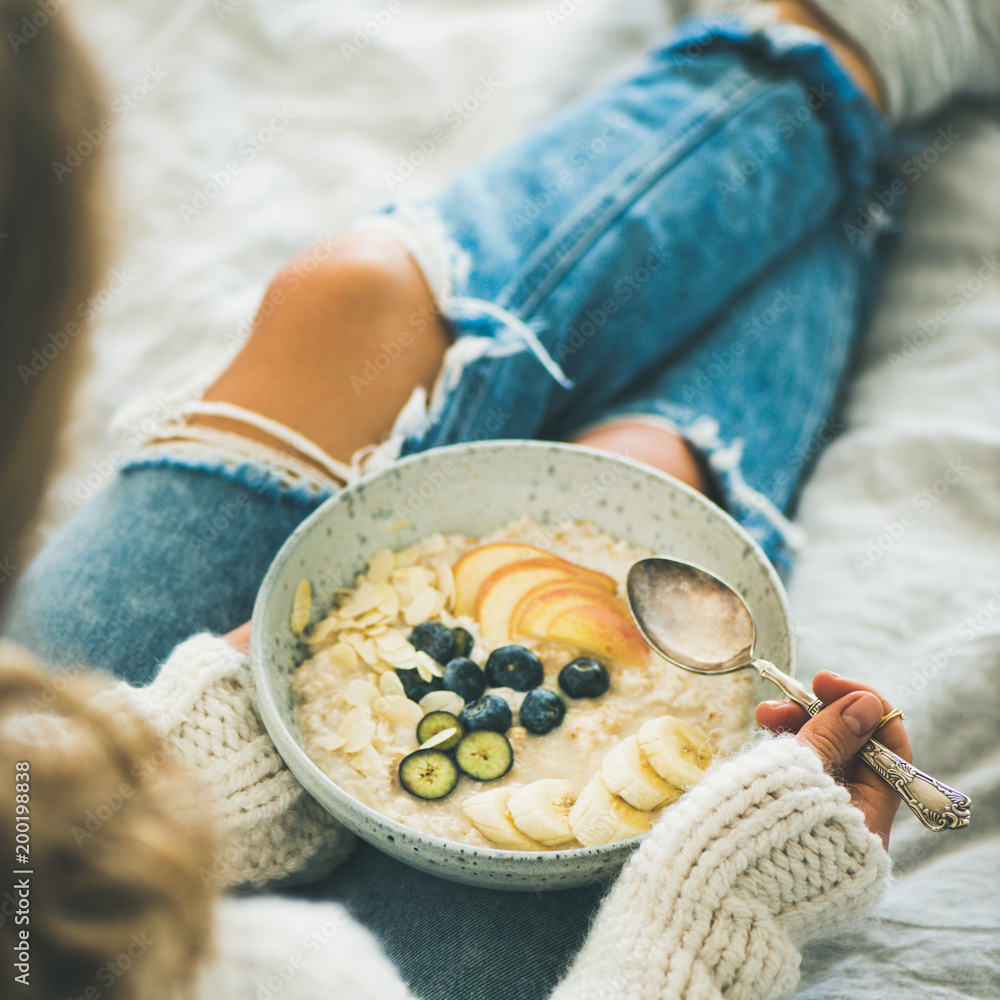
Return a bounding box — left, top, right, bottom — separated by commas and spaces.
39, 0, 1000, 1000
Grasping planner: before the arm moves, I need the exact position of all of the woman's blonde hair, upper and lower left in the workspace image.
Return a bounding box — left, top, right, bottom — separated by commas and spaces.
0, 0, 214, 1000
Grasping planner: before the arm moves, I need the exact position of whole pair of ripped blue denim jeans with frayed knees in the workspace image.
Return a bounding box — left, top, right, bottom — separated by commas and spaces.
6, 13, 888, 1000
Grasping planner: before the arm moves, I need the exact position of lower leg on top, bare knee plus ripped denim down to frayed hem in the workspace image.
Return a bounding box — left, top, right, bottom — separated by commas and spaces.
174, 12, 882, 484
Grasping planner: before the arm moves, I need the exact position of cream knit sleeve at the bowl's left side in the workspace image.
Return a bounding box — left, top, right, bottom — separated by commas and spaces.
114, 635, 354, 887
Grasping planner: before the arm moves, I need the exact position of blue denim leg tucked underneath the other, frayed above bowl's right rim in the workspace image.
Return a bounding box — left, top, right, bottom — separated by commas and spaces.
552, 227, 878, 572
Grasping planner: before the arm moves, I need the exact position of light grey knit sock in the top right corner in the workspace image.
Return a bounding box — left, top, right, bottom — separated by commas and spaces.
811, 0, 1000, 124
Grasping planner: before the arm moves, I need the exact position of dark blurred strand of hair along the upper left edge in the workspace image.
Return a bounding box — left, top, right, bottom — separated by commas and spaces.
0, 0, 103, 580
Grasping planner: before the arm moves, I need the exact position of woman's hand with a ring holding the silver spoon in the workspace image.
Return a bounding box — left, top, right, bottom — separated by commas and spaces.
757, 670, 913, 848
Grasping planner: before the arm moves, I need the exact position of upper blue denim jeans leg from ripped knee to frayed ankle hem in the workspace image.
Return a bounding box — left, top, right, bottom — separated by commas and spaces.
358, 18, 886, 458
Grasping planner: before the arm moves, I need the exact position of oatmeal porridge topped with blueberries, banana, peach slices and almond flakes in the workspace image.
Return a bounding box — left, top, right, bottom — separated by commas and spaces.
293, 518, 754, 850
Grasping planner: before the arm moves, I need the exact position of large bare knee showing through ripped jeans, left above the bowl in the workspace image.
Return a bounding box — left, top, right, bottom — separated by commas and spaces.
191, 230, 451, 462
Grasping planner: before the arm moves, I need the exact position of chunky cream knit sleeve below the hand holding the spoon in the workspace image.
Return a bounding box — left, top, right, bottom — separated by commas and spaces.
553, 737, 889, 1000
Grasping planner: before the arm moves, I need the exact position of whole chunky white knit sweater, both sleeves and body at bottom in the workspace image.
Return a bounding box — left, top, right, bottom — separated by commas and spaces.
118, 635, 889, 1000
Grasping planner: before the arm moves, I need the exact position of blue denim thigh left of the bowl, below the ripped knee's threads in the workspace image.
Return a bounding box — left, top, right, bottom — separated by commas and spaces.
3, 465, 321, 685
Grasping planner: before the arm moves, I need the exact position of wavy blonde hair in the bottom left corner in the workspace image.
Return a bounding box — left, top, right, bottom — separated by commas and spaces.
0, 646, 215, 1000
